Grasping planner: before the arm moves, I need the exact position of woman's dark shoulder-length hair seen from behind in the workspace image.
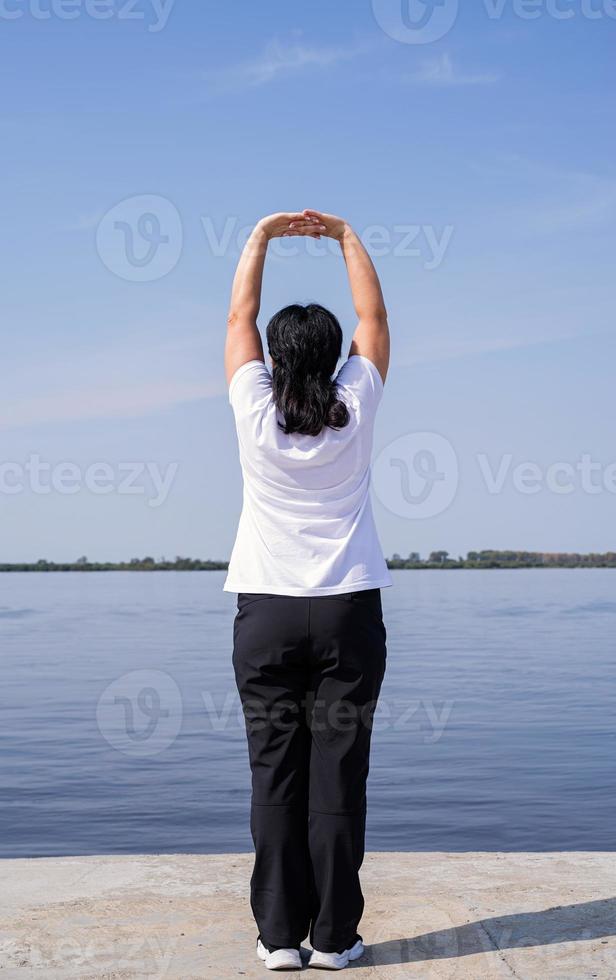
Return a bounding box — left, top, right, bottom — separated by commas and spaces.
267, 303, 349, 436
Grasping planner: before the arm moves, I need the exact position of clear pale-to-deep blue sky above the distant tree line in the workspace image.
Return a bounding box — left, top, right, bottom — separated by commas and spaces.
0, 0, 616, 561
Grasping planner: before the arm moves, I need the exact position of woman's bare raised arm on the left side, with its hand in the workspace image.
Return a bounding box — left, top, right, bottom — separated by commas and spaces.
225, 212, 325, 383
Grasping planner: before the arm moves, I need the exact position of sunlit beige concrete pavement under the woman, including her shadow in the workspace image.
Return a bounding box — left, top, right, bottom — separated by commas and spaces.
0, 852, 616, 980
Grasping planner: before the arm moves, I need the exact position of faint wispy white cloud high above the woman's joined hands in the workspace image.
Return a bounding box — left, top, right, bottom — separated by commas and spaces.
207, 38, 366, 91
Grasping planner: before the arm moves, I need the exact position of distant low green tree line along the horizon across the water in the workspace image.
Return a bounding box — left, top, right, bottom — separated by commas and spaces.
0, 551, 616, 572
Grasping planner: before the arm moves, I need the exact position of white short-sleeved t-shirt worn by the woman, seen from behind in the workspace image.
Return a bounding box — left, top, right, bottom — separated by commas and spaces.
224, 355, 392, 596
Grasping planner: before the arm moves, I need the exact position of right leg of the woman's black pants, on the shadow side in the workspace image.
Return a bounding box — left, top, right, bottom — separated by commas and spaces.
309, 589, 386, 952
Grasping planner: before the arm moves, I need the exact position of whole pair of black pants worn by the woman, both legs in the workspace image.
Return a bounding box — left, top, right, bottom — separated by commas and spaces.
233, 589, 386, 953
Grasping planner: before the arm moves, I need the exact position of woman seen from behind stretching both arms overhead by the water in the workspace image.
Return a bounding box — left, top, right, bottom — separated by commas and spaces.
224, 211, 392, 970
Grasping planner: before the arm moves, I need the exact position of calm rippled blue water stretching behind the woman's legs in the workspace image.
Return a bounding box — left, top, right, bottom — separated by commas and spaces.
0, 569, 616, 857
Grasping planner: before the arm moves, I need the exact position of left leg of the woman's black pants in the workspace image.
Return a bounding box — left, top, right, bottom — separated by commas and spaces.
233, 593, 312, 947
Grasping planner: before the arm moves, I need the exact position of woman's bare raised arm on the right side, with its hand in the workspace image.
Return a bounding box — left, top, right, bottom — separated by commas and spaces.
292, 210, 390, 381
